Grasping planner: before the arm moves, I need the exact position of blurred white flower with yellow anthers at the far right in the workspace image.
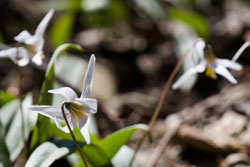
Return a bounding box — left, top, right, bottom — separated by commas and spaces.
172, 39, 249, 89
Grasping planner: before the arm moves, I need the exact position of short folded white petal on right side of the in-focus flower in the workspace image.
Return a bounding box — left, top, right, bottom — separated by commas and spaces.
75, 98, 97, 114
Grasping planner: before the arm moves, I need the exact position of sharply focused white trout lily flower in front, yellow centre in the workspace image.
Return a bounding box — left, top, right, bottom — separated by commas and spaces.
28, 55, 97, 144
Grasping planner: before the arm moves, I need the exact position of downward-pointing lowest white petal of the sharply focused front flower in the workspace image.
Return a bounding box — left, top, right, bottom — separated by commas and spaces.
78, 116, 90, 144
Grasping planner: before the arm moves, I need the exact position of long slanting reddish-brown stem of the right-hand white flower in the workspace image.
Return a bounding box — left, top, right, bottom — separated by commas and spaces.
129, 51, 189, 167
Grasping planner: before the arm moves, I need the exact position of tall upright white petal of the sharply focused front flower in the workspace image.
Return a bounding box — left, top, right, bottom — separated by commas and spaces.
81, 54, 95, 98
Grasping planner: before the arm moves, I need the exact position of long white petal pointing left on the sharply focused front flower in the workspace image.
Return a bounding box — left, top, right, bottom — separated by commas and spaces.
28, 105, 66, 120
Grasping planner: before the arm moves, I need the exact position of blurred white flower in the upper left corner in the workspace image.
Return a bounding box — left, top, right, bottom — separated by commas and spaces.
0, 9, 54, 66
